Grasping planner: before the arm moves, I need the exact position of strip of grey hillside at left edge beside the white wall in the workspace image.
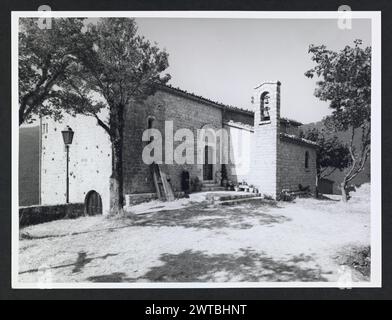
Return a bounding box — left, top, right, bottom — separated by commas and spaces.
19, 126, 39, 206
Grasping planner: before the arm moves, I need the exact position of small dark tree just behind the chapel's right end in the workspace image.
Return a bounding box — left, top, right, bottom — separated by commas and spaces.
301, 128, 351, 197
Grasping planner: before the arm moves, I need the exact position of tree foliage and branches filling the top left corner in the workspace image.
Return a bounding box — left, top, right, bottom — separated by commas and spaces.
19, 18, 83, 125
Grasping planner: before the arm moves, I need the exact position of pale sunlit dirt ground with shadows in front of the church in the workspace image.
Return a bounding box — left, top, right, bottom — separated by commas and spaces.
19, 186, 370, 287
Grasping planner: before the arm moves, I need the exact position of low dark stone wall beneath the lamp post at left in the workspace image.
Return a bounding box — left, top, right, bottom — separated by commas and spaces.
19, 203, 85, 227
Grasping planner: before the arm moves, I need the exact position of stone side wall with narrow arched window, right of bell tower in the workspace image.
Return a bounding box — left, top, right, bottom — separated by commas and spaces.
277, 140, 316, 194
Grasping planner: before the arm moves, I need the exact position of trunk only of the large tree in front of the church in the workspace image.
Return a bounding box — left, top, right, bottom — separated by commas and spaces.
110, 106, 124, 214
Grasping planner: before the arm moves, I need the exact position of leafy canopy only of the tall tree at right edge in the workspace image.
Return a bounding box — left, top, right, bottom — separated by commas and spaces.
305, 40, 371, 131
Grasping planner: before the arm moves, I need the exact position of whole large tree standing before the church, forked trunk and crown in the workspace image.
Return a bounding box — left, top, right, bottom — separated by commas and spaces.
55, 18, 170, 214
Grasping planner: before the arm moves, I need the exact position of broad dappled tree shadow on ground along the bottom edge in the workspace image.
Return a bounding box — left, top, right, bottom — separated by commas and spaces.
87, 249, 328, 282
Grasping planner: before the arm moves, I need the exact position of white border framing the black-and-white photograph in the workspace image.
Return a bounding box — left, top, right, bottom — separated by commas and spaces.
11, 11, 382, 289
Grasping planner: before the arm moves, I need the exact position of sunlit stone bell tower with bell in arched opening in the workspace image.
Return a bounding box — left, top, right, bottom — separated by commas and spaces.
248, 81, 280, 199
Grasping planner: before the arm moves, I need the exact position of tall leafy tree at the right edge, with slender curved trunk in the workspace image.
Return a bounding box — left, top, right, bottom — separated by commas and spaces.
305, 40, 371, 201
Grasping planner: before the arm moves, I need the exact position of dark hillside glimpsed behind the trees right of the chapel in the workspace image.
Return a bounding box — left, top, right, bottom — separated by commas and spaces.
301, 121, 370, 194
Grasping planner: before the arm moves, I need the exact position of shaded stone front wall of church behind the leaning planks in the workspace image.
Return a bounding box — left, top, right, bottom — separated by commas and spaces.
123, 90, 222, 194
